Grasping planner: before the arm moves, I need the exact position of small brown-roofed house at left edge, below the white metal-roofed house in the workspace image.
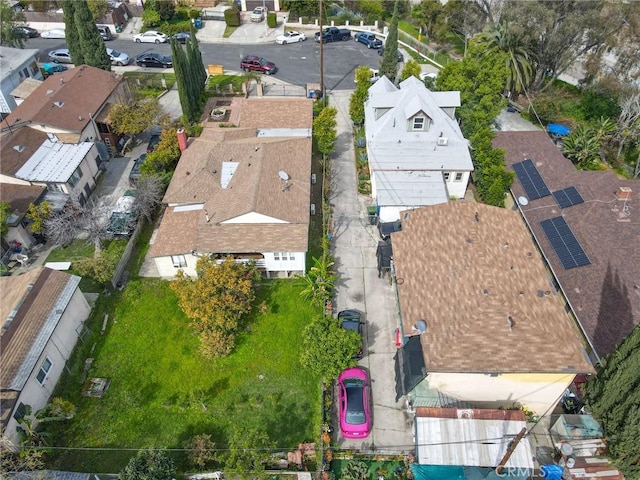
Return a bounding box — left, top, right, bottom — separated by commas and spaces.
0, 183, 46, 250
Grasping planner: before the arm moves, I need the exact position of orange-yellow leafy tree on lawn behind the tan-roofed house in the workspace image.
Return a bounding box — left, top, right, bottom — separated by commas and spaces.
171, 257, 260, 357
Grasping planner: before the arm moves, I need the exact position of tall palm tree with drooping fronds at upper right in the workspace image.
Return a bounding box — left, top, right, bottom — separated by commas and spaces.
478, 23, 535, 96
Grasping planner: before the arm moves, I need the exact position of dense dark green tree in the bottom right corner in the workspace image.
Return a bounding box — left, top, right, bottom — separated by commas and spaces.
585, 326, 640, 478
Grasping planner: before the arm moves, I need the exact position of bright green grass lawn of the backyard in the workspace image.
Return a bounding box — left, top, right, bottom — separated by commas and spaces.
49, 279, 321, 472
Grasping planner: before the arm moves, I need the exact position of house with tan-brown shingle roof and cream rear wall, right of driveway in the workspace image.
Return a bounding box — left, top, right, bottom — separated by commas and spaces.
392, 201, 593, 415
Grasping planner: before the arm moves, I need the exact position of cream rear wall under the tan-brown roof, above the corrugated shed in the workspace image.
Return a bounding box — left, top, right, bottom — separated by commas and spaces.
425, 372, 575, 415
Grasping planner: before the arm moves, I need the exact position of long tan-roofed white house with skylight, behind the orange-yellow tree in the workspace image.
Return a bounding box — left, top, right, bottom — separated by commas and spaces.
149, 98, 312, 278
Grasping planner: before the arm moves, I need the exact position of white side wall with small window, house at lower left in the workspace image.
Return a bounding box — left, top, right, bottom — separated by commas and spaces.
5, 288, 91, 443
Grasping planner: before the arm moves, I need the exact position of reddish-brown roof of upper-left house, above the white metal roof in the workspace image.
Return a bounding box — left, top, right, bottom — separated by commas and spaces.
6, 65, 124, 132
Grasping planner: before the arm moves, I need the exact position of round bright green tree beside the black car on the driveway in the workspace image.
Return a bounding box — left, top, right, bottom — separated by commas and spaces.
300, 315, 362, 381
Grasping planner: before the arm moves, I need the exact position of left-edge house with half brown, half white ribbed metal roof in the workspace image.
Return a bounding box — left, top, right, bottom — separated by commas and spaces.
0, 127, 101, 203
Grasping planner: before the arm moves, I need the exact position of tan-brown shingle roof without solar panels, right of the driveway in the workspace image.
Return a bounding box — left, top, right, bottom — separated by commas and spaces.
392, 201, 592, 373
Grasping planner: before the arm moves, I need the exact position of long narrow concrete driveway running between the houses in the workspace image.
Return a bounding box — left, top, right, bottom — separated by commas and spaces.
329, 90, 414, 453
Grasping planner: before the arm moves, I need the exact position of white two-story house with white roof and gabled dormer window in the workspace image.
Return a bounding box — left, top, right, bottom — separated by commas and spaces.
365, 77, 473, 222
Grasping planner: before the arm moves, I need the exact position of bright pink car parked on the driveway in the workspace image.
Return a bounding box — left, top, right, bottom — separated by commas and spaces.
338, 367, 371, 438
